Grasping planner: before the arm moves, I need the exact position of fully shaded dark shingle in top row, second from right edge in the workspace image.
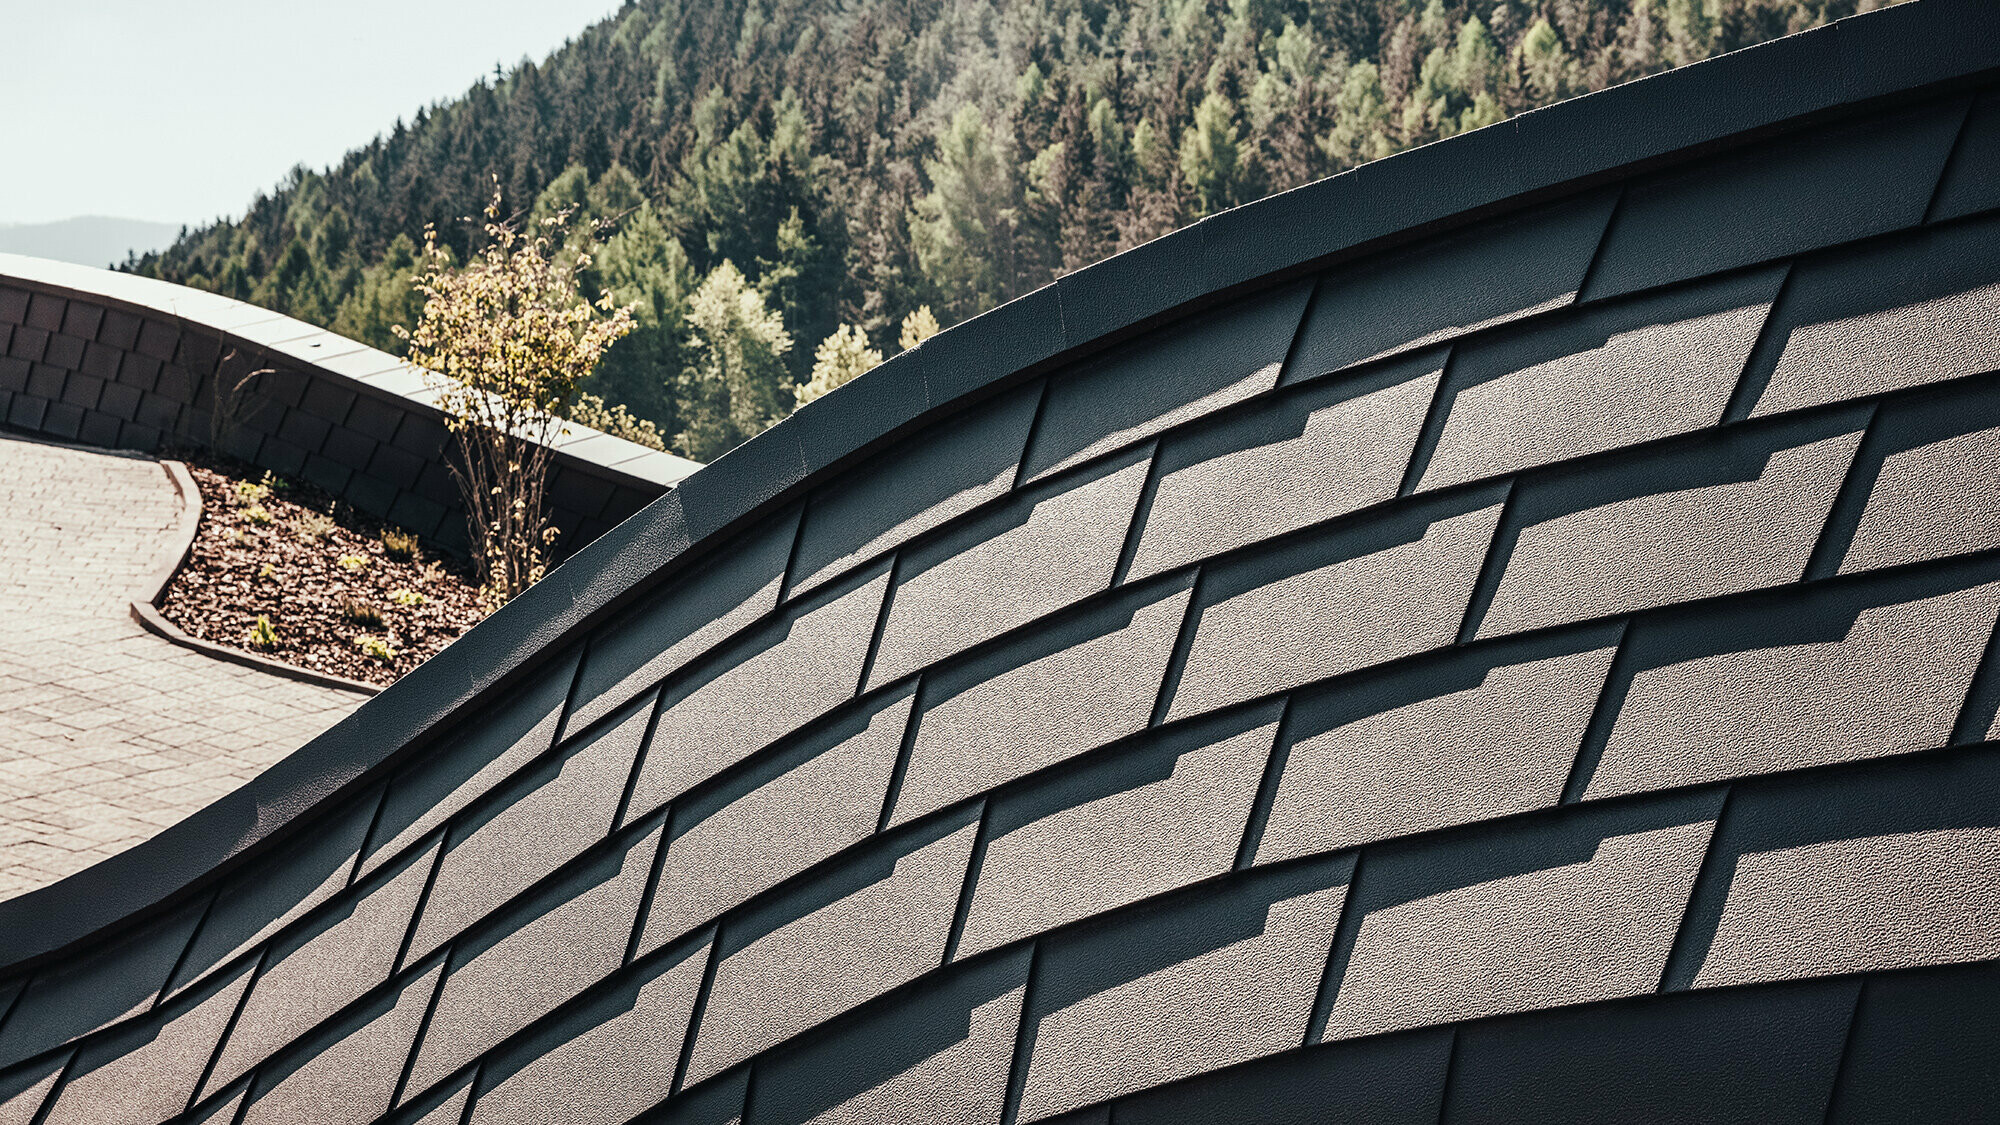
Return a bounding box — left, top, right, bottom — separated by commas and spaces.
1584, 96, 1968, 300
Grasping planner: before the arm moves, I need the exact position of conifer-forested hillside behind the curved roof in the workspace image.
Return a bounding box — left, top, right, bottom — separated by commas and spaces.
128, 0, 1882, 458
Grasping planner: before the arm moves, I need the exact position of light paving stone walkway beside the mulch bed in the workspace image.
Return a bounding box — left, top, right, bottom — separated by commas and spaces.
0, 434, 362, 899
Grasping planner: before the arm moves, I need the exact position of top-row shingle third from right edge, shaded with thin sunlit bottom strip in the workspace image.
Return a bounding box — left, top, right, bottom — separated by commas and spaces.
1284, 192, 1616, 382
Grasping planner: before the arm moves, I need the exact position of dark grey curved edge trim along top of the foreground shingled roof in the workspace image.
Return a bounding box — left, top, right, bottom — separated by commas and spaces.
0, 0, 2000, 965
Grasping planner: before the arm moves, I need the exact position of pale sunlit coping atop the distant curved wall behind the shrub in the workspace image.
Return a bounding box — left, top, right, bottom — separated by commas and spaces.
0, 254, 700, 490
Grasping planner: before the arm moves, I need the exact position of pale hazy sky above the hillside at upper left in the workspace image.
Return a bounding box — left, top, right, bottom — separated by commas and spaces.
0, 0, 618, 224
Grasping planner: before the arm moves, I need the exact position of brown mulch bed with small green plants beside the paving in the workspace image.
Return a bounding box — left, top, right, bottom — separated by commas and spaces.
160, 456, 486, 685
